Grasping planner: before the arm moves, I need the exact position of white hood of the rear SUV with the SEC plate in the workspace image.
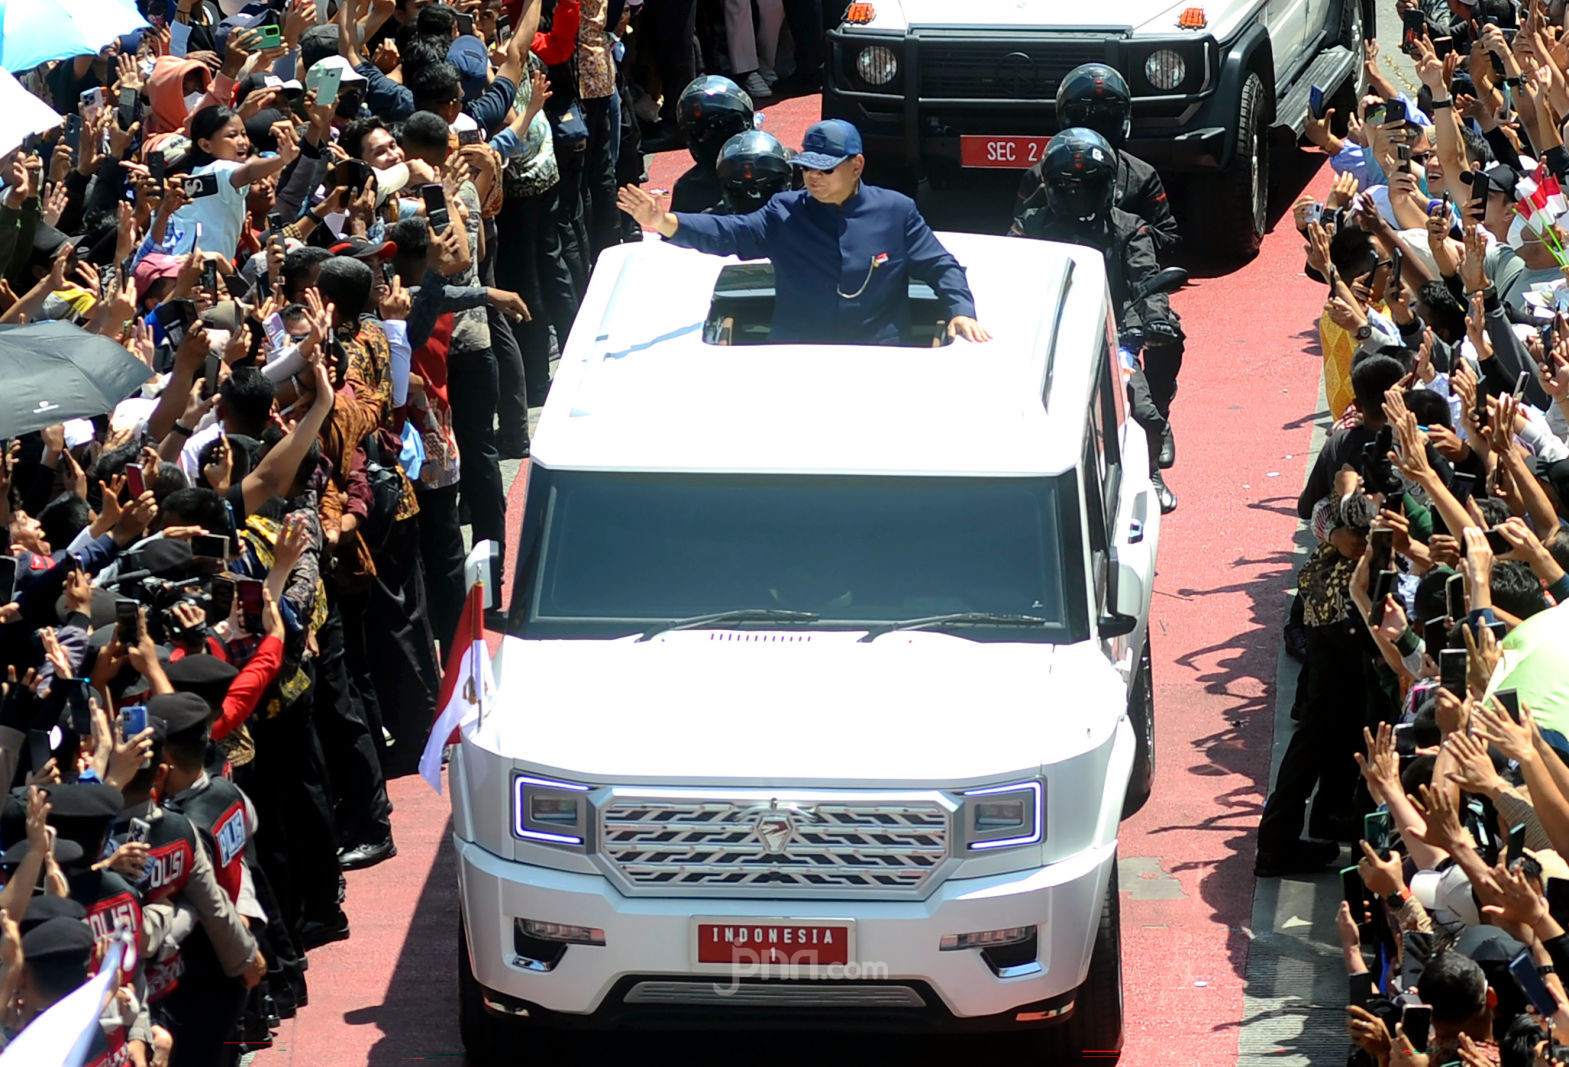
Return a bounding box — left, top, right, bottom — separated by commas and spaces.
874, 0, 1192, 32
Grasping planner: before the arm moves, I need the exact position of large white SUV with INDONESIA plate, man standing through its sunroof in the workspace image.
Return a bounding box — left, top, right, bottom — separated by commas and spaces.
450, 234, 1159, 1056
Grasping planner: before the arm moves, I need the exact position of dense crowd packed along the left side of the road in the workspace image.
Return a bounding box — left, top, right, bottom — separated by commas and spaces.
0, 0, 846, 1067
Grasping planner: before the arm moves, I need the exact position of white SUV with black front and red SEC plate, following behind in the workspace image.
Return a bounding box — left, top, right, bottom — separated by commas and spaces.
822, 0, 1373, 254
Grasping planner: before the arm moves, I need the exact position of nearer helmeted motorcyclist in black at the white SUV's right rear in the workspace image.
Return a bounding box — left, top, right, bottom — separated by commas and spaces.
1010, 129, 1177, 512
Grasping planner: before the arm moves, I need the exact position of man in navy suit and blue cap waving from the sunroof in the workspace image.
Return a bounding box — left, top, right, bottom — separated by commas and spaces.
617, 119, 992, 345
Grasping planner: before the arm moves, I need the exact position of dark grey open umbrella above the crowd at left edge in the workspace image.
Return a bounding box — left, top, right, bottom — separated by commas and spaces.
0, 322, 152, 438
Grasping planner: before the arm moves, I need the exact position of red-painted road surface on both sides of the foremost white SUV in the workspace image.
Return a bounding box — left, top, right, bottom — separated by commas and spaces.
257, 97, 1326, 1067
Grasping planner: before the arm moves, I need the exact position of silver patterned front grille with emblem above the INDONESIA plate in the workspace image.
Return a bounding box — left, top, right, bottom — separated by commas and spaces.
599, 794, 951, 896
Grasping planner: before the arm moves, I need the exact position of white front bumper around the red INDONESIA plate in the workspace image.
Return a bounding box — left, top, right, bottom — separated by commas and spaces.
455, 838, 1116, 1029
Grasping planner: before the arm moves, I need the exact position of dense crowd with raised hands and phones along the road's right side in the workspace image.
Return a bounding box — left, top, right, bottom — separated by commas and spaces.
1255, 0, 1569, 1067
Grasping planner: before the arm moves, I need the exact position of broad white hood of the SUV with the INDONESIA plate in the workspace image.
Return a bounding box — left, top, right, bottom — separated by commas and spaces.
474, 631, 1125, 786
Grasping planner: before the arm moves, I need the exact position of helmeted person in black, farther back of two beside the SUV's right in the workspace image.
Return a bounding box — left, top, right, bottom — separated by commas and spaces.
1014, 63, 1183, 468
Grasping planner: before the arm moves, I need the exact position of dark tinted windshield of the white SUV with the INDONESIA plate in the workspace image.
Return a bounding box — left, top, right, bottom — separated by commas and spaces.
513, 468, 1084, 640
